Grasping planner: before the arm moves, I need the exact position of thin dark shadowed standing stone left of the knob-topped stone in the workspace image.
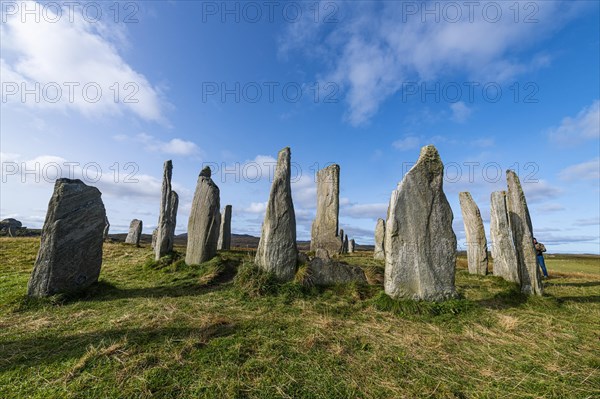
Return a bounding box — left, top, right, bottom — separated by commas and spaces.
154, 160, 179, 260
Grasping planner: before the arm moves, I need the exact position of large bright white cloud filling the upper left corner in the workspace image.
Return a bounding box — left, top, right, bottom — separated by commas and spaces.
0, 1, 164, 121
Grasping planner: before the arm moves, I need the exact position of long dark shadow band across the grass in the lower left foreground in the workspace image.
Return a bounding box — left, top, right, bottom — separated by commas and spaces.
0, 320, 236, 372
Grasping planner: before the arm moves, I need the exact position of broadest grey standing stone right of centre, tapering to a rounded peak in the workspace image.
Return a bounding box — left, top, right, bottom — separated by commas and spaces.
384, 145, 456, 300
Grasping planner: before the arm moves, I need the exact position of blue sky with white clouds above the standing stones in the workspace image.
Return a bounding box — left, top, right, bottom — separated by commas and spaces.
0, 0, 600, 254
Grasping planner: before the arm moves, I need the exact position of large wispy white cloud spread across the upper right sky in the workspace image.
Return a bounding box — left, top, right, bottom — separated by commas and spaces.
280, 1, 583, 125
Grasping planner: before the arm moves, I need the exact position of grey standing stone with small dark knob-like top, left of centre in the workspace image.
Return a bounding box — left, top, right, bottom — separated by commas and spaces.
185, 166, 221, 265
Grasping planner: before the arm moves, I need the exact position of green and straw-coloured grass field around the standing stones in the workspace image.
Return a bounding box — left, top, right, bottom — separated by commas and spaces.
0, 238, 600, 399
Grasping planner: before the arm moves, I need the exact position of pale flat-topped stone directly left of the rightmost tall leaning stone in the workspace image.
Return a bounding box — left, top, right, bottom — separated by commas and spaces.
490, 191, 520, 284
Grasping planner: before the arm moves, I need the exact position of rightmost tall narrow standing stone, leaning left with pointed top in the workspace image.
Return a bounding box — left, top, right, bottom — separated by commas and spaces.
506, 170, 542, 295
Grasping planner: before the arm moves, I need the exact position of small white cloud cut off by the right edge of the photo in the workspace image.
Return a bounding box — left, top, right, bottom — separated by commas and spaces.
548, 100, 600, 144
